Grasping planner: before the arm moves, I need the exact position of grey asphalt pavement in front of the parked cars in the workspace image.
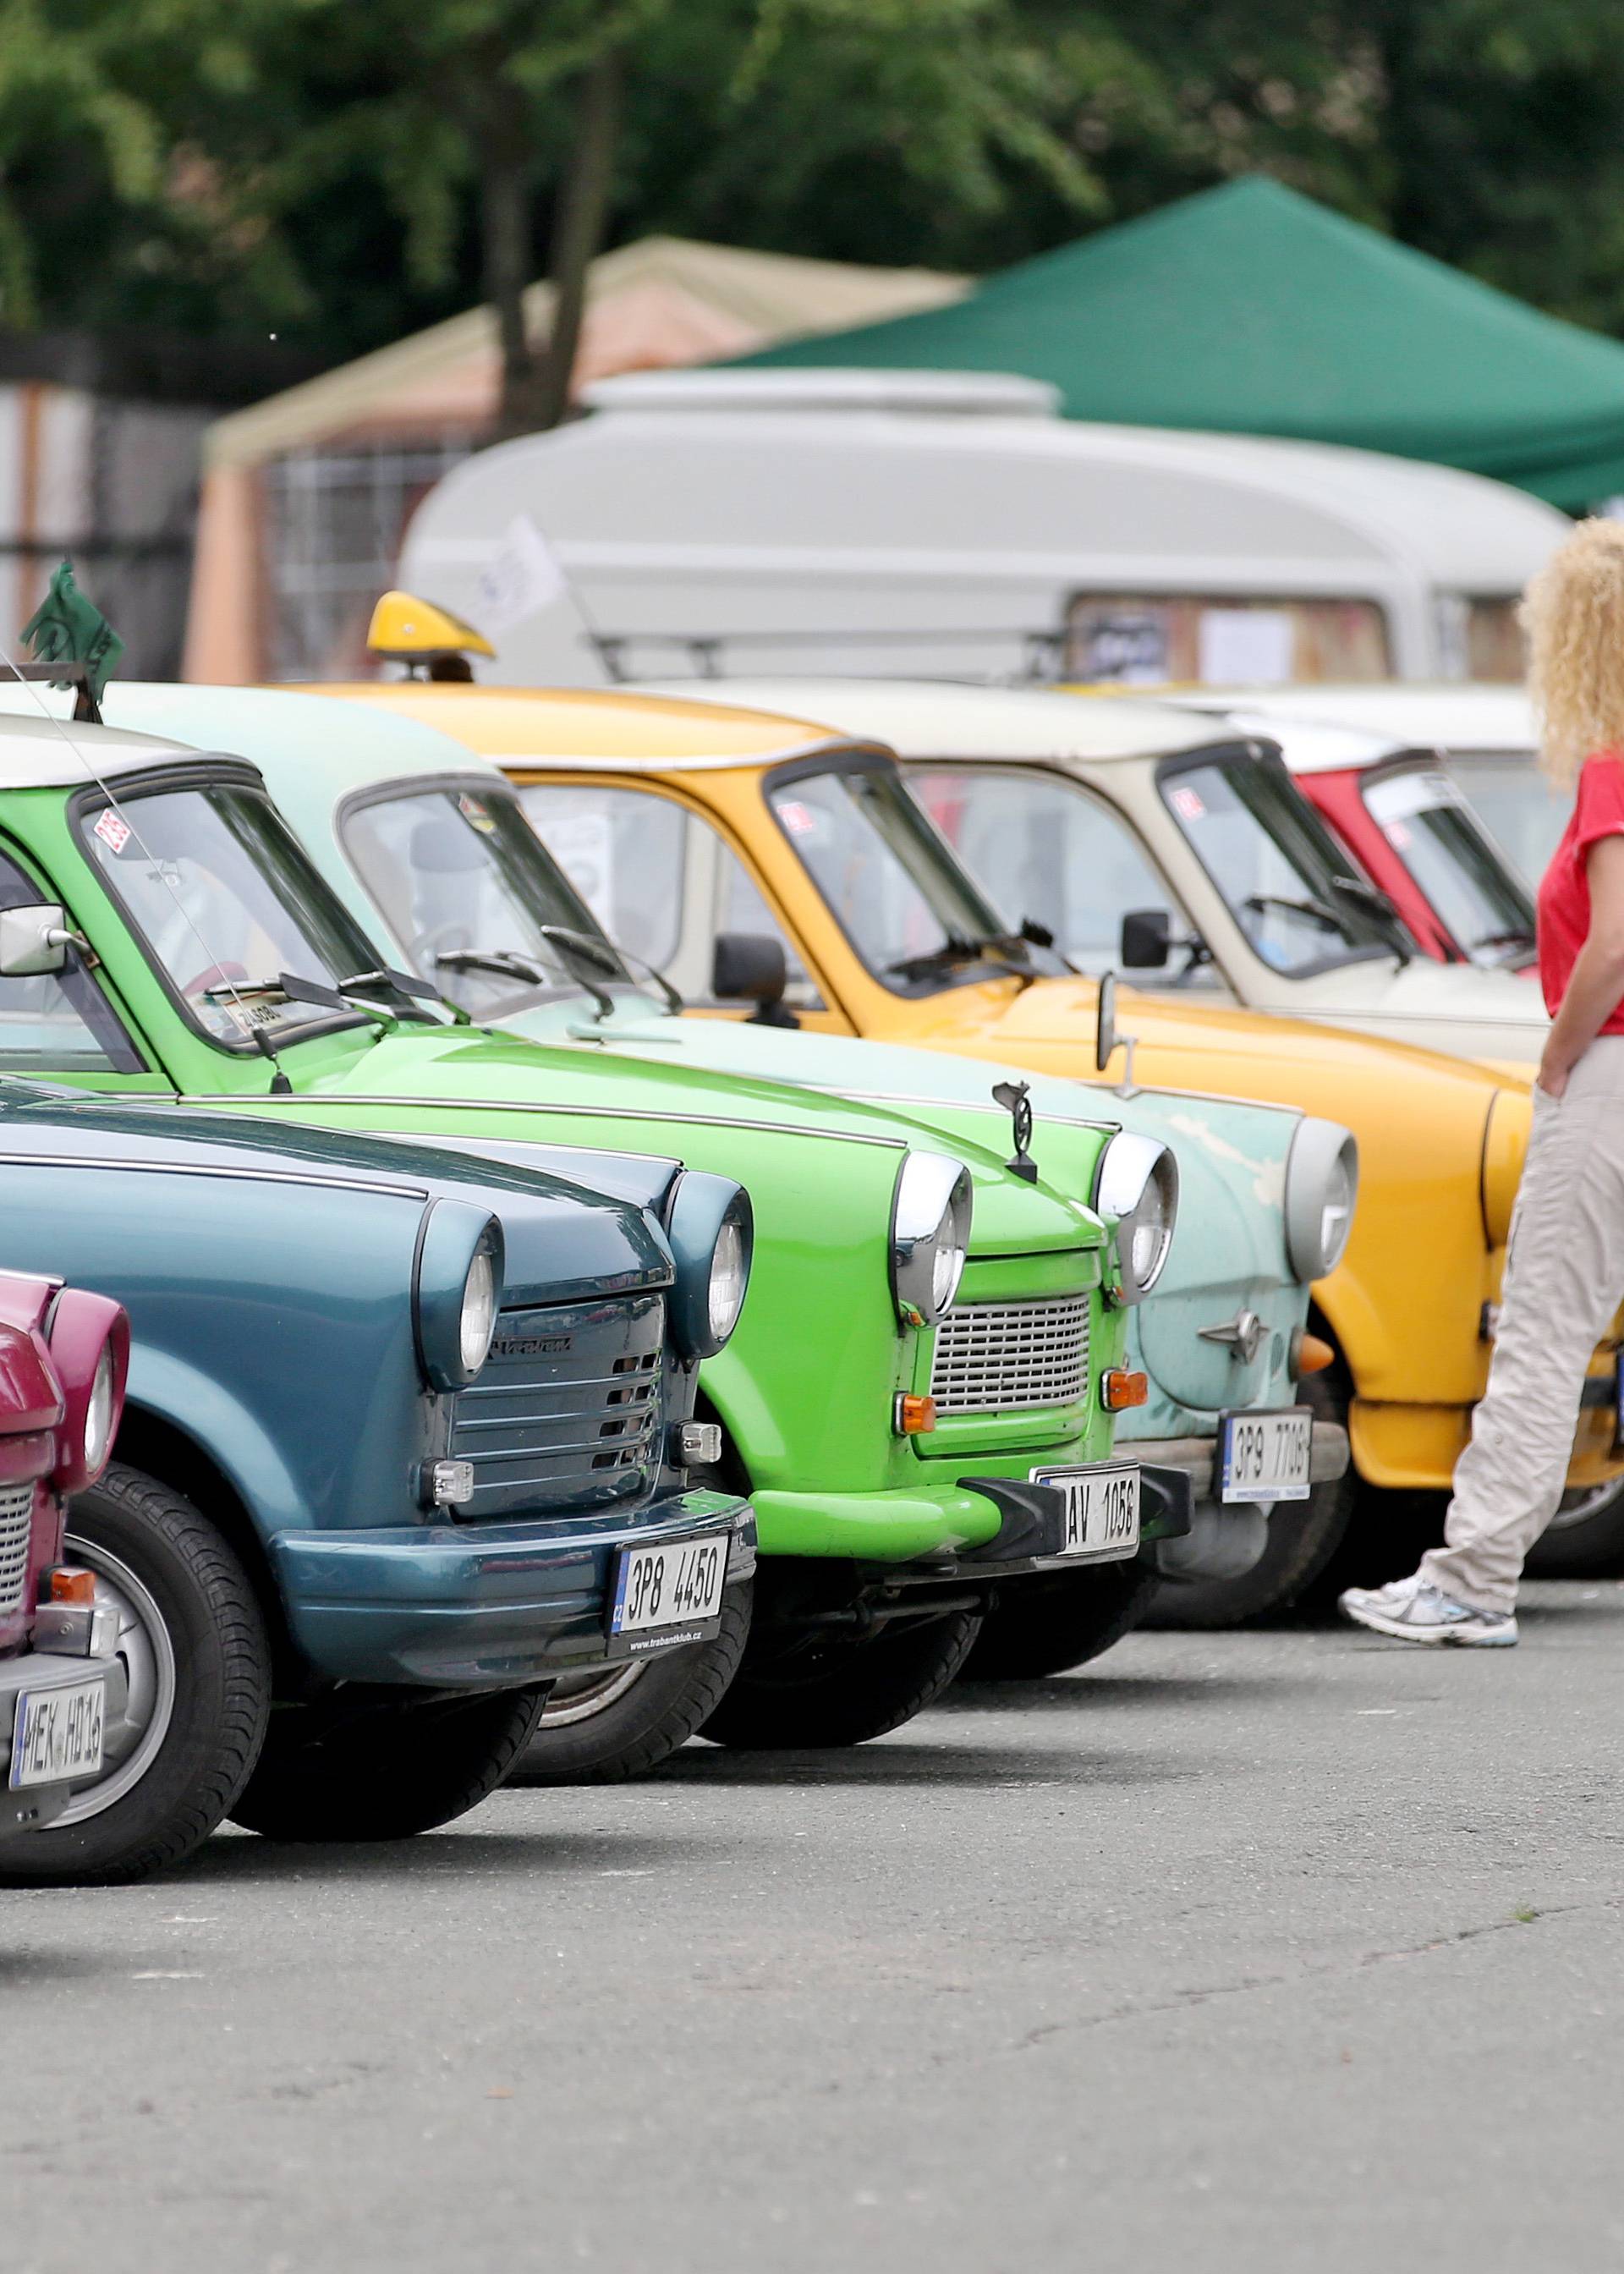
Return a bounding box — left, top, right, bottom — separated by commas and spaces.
0, 1583, 1624, 2274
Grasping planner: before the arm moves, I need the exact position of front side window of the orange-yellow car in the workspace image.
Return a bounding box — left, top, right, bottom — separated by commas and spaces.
518, 783, 823, 1009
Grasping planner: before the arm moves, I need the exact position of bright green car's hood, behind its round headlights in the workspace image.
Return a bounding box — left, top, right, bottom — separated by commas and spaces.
284, 1028, 1106, 1255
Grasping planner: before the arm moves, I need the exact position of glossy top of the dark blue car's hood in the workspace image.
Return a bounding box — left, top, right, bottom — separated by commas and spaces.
0, 1082, 678, 1303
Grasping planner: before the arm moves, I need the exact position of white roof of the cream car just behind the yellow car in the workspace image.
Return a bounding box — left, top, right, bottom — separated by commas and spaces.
639, 678, 1235, 764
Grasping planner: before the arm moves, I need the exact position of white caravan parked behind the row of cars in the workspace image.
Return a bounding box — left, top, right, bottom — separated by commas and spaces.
400, 371, 1569, 684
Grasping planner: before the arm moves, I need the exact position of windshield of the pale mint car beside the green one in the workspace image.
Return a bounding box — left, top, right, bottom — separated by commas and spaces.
343, 787, 633, 1017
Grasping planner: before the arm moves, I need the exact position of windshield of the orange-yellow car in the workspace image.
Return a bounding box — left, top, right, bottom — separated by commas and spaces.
766, 766, 1064, 994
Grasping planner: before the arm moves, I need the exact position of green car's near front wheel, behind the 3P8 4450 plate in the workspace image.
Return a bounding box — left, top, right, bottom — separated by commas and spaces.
508, 1580, 750, 1785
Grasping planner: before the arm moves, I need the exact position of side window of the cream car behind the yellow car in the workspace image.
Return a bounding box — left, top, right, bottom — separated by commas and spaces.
908, 766, 1212, 987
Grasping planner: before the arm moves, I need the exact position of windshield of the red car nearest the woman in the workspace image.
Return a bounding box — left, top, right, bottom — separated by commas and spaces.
1360, 764, 1533, 964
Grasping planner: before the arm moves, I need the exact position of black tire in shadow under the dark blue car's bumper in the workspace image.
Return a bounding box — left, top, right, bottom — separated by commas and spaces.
232, 1687, 546, 1840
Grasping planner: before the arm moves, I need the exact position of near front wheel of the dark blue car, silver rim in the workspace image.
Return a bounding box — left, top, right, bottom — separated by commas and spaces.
0, 1464, 271, 1887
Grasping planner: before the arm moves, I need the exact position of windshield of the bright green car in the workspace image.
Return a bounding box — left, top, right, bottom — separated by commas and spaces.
75, 783, 412, 1048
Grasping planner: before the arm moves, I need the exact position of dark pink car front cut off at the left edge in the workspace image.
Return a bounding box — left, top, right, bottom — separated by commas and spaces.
0, 1272, 129, 1837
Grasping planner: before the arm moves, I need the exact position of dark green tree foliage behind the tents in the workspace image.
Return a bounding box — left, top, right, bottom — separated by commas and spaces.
0, 0, 1624, 354
